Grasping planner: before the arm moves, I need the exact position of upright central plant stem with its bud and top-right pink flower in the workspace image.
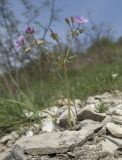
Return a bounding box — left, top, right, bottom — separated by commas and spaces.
50, 16, 88, 129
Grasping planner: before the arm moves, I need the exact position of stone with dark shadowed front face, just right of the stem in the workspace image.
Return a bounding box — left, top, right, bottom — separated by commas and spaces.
77, 106, 106, 122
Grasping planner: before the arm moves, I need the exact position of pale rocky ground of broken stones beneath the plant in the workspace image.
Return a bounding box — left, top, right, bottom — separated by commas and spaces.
0, 91, 122, 160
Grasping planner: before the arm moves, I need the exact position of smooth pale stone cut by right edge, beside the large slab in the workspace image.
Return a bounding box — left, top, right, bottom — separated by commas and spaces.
106, 122, 122, 138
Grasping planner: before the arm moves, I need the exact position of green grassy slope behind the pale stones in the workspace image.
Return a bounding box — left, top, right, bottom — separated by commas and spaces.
0, 37, 122, 131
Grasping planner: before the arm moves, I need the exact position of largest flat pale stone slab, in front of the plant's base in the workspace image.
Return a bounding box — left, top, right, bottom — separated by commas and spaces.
15, 130, 93, 155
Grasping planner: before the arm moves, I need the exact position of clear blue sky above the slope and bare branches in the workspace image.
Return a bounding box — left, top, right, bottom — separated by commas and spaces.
13, 0, 122, 40
